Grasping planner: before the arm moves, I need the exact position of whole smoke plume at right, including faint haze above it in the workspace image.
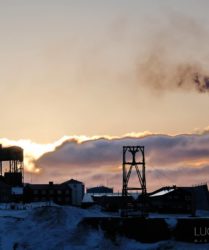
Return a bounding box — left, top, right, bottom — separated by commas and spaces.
135, 13, 209, 93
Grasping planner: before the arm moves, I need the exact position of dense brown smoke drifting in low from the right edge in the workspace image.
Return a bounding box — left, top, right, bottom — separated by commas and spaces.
137, 55, 209, 93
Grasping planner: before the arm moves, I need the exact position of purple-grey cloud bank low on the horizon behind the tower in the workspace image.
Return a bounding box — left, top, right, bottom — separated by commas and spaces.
34, 133, 209, 191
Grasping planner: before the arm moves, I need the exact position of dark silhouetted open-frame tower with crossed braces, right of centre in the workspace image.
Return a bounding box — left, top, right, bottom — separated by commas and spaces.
122, 146, 147, 196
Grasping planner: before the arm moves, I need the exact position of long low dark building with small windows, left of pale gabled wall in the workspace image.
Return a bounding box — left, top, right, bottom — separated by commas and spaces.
24, 182, 72, 205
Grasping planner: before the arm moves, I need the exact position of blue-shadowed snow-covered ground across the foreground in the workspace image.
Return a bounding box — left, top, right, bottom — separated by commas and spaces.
0, 203, 209, 250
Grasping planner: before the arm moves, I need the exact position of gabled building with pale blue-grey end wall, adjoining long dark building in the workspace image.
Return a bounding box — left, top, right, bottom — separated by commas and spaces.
62, 179, 85, 206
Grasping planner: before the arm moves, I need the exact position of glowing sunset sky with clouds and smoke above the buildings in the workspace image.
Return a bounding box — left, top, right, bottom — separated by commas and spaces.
0, 0, 209, 189
